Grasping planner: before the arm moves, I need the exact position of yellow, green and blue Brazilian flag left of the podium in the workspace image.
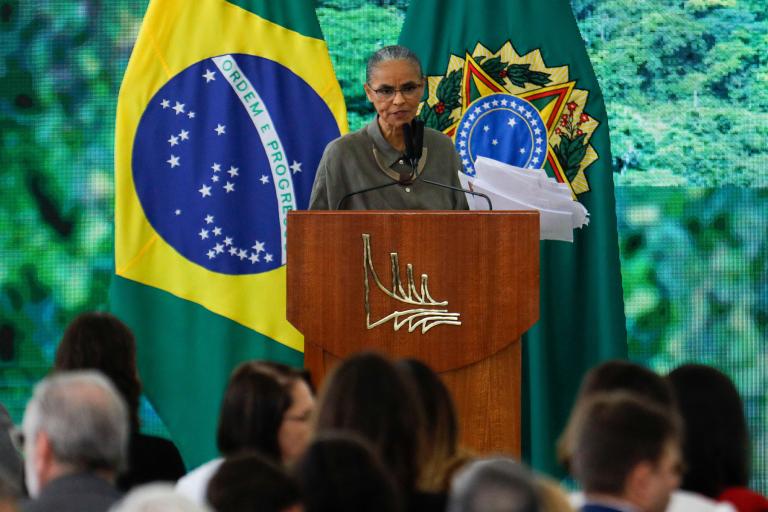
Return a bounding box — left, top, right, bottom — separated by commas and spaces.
111, 0, 347, 466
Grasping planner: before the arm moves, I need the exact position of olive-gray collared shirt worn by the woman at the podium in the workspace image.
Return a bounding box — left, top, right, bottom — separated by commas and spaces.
309, 119, 468, 210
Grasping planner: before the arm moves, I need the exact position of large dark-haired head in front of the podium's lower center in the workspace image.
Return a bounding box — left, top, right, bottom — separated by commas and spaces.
316, 352, 423, 492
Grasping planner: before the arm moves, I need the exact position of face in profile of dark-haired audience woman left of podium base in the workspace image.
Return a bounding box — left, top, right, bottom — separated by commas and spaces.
277, 380, 315, 464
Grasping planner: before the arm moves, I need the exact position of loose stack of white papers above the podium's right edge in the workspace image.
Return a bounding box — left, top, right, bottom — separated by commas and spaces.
459, 156, 589, 242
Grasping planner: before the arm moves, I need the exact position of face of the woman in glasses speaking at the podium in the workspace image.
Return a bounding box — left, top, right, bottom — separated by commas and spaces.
364, 60, 424, 133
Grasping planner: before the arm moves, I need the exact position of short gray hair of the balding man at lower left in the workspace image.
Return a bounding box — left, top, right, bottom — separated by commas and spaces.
23, 371, 128, 471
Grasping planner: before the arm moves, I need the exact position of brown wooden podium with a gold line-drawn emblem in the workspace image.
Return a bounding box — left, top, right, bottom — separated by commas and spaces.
287, 211, 539, 455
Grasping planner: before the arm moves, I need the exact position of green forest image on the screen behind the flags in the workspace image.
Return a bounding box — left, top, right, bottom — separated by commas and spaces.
0, 0, 768, 492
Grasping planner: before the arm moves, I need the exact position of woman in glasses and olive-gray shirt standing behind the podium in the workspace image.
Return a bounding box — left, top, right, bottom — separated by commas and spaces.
309, 46, 467, 210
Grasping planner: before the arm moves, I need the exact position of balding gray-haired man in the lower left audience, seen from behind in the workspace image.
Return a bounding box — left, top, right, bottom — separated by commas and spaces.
22, 371, 128, 512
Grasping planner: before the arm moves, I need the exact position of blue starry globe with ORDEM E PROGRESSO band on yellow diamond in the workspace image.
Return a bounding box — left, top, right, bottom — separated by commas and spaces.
132, 54, 339, 274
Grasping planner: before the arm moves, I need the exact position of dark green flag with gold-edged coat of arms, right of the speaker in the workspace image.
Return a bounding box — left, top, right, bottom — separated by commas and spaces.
399, 0, 626, 473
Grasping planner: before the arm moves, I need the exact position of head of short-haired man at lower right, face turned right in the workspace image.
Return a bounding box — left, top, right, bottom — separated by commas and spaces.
571, 391, 681, 512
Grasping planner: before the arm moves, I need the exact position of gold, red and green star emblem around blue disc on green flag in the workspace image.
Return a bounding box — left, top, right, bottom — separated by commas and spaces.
419, 41, 600, 197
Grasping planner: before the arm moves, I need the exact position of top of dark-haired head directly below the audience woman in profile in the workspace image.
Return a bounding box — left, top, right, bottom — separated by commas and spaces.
207, 453, 301, 512
